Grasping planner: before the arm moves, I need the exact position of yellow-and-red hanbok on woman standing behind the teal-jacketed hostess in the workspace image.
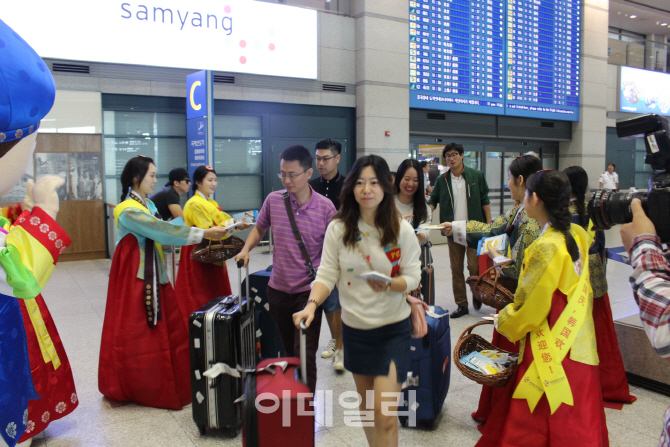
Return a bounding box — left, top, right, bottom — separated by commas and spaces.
175, 191, 234, 326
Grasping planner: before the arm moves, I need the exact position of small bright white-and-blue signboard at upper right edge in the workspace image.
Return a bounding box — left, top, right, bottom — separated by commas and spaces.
619, 67, 670, 116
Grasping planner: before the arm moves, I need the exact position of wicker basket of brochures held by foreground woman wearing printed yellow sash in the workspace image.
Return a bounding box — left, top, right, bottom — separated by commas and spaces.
453, 321, 517, 388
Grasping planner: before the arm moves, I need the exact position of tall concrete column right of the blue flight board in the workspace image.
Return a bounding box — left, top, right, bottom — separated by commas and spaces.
558, 0, 609, 188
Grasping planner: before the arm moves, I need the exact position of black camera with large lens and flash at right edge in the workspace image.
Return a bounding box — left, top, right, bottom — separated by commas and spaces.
588, 113, 670, 243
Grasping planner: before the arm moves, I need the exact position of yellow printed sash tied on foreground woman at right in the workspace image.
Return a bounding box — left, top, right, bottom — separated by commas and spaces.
512, 258, 589, 414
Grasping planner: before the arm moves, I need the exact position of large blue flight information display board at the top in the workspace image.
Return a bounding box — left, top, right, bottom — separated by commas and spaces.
409, 0, 581, 121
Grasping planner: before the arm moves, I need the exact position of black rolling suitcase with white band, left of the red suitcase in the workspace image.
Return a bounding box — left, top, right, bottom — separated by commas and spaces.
189, 266, 256, 437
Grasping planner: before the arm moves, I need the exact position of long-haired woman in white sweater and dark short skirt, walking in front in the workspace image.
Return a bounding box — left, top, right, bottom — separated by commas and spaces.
293, 155, 421, 446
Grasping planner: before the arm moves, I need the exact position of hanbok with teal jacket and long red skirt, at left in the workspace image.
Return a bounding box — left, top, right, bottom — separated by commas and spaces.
98, 192, 204, 410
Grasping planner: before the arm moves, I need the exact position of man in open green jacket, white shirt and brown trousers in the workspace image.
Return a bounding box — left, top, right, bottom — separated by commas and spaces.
428, 143, 491, 318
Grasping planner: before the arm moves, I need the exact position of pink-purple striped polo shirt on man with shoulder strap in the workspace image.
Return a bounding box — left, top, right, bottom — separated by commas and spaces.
256, 186, 336, 293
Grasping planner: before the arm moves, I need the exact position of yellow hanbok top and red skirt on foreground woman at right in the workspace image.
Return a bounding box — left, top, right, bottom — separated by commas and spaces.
477, 228, 609, 447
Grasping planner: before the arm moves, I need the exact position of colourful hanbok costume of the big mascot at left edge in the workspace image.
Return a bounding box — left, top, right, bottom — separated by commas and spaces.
0, 206, 72, 447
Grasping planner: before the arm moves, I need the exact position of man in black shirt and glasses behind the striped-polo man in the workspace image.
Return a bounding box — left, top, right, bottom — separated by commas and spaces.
309, 138, 344, 371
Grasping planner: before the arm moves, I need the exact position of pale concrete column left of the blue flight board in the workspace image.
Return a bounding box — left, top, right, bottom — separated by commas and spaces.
352, 0, 409, 171
